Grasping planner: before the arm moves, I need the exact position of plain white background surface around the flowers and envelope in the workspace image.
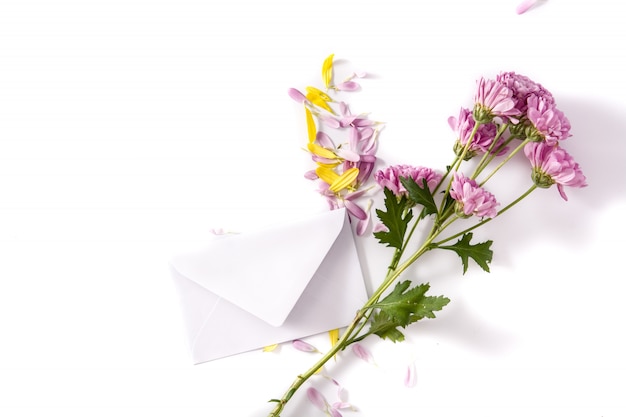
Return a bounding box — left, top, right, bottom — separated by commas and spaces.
0, 0, 626, 417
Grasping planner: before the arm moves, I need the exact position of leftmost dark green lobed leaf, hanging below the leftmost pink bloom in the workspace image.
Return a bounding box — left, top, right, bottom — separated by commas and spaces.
374, 188, 413, 249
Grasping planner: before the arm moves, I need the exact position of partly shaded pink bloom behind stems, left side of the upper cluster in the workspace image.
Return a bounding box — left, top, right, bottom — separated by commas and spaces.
448, 108, 506, 161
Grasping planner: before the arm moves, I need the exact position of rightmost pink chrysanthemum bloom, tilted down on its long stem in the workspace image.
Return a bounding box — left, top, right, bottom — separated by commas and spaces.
524, 142, 587, 201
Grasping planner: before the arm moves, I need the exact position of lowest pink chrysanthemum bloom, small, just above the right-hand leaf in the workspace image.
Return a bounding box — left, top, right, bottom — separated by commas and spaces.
450, 172, 499, 218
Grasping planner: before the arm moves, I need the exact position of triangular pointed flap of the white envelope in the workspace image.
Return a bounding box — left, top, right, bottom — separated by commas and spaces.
172, 209, 347, 326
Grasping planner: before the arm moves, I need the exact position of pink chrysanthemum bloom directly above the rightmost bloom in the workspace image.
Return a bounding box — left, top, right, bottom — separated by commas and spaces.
527, 96, 571, 146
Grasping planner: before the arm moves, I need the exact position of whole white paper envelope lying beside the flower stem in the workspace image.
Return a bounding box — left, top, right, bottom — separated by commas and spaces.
171, 209, 367, 363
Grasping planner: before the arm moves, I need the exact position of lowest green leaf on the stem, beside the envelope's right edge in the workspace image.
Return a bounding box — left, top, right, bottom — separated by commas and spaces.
369, 281, 450, 342
